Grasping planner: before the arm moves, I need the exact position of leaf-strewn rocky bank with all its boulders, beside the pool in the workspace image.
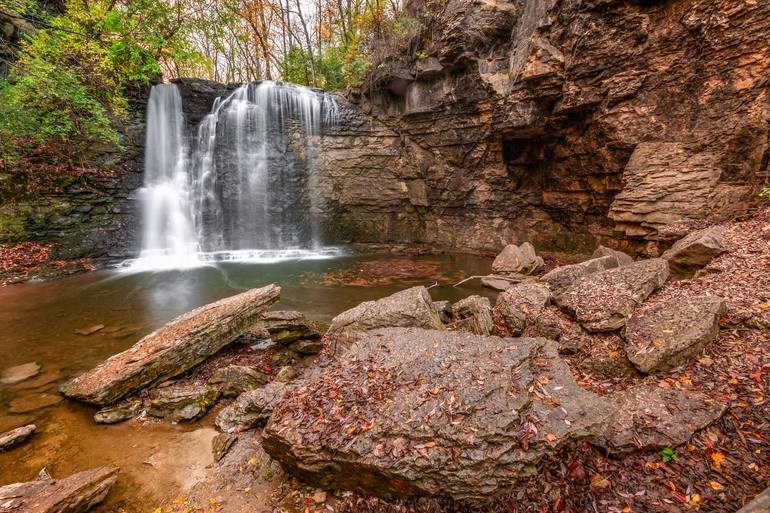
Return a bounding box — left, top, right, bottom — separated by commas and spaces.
0, 213, 770, 512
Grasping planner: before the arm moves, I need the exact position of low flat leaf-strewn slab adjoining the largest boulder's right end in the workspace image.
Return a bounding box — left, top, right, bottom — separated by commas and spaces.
597, 384, 727, 452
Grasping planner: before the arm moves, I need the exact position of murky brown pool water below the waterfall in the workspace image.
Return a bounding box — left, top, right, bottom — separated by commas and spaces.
0, 250, 494, 512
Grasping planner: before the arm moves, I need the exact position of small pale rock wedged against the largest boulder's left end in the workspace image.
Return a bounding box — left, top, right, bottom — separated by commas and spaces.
215, 382, 297, 433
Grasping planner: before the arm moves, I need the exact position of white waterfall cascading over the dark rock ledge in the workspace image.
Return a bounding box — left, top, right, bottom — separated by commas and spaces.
125, 82, 339, 270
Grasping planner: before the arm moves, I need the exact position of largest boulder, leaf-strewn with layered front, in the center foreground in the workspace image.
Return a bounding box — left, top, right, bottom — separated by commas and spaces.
263, 328, 614, 499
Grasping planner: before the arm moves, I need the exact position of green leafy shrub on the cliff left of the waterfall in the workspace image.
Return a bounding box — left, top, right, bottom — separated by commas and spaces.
0, 0, 198, 192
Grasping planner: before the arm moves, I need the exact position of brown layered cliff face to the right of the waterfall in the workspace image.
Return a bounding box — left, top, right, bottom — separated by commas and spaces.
316, 0, 770, 254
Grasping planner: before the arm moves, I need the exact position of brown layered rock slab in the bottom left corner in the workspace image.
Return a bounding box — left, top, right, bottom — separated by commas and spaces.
0, 467, 118, 513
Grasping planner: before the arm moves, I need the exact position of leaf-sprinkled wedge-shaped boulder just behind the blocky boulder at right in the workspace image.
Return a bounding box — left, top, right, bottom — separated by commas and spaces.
555, 257, 668, 331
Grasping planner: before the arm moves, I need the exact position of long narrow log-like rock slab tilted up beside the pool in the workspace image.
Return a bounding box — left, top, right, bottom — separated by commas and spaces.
61, 285, 281, 406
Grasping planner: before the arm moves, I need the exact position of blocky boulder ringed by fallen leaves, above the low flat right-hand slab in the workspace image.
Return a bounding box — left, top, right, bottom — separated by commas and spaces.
625, 296, 725, 374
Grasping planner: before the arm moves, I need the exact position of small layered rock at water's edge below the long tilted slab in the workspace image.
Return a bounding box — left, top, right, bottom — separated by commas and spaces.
147, 385, 219, 422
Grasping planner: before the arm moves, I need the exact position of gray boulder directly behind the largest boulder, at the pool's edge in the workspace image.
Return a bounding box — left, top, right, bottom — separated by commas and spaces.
325, 287, 444, 349
